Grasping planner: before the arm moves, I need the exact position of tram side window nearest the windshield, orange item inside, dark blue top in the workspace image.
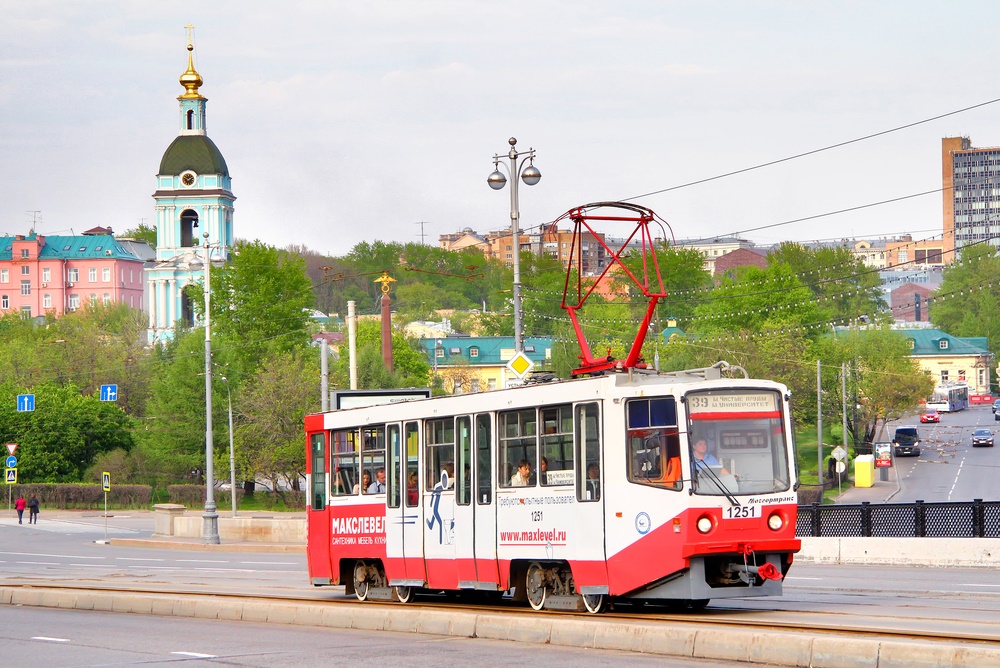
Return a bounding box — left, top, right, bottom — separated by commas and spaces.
625, 397, 684, 490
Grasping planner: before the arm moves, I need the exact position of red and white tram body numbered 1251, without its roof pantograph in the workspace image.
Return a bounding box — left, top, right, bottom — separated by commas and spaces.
305, 364, 799, 612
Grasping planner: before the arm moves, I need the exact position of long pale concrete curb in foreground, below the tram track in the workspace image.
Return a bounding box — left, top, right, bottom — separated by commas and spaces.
0, 586, 1000, 668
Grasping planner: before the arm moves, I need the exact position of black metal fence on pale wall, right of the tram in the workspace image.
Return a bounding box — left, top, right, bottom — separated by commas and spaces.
795, 499, 1000, 538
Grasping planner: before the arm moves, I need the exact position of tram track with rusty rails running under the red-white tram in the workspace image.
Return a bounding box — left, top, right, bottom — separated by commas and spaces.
0, 579, 1000, 651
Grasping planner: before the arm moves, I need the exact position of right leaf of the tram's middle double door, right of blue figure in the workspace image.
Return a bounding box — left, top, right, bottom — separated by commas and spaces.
472, 413, 500, 589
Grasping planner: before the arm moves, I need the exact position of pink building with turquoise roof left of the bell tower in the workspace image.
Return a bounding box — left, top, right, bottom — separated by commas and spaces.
0, 230, 148, 318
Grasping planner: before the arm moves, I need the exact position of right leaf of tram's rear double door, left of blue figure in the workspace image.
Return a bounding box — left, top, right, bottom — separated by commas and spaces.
394, 422, 427, 587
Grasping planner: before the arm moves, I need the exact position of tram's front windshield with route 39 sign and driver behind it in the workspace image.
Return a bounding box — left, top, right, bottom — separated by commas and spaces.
686, 389, 791, 496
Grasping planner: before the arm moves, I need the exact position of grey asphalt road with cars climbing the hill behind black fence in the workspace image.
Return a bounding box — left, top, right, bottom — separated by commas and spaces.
887, 406, 1000, 503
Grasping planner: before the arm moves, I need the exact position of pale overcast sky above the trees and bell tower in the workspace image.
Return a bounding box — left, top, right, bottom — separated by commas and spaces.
0, 0, 1000, 255
